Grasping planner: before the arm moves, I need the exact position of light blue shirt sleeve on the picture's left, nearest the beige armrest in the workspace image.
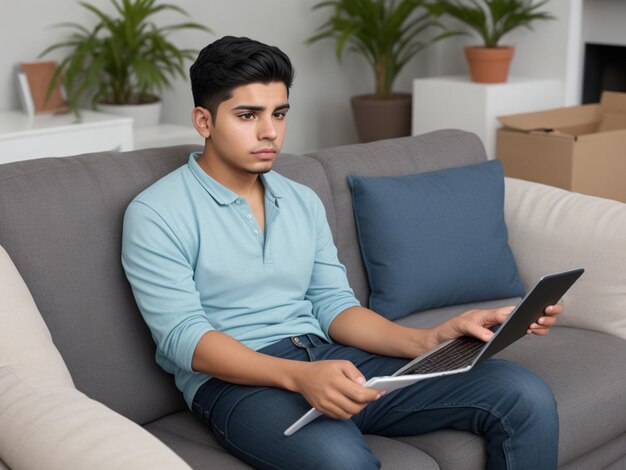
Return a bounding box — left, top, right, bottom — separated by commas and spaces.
122, 201, 215, 372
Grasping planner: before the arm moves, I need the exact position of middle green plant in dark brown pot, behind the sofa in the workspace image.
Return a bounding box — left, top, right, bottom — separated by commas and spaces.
307, 0, 455, 142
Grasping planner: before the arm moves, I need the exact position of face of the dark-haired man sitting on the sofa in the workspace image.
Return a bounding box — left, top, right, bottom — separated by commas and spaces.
205, 82, 289, 174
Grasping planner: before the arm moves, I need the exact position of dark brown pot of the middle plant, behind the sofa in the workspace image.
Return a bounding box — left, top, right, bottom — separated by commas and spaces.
352, 93, 412, 142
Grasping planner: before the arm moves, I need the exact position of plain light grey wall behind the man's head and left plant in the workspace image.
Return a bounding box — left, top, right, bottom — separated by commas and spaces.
0, 0, 433, 153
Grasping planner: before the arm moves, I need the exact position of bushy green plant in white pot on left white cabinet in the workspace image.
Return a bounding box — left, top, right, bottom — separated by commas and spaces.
41, 0, 210, 127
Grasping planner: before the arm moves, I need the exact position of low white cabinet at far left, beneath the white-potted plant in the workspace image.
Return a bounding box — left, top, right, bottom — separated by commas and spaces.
0, 110, 133, 164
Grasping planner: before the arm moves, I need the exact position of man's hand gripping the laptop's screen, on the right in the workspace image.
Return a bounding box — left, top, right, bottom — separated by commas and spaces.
431, 304, 563, 347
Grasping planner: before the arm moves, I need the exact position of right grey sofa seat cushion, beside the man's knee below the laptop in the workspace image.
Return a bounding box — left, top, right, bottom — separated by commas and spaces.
390, 327, 626, 470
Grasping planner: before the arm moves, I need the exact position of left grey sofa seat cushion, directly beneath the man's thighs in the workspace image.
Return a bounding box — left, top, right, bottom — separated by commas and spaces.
145, 411, 439, 470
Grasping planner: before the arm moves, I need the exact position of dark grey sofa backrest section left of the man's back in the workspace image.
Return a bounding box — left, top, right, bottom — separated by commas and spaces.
0, 147, 191, 423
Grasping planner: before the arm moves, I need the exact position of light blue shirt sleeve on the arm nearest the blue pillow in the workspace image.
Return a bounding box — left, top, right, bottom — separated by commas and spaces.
305, 196, 360, 338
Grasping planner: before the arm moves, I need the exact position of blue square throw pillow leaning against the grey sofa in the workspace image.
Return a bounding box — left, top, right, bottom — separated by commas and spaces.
348, 160, 524, 320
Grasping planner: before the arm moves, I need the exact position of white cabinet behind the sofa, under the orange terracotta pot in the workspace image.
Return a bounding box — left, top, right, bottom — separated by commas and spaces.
412, 76, 564, 158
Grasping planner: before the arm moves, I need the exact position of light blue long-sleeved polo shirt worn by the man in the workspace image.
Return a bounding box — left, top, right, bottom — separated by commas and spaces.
122, 153, 359, 407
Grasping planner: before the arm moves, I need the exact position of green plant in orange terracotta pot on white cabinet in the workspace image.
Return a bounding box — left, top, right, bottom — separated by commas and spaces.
431, 0, 554, 83
